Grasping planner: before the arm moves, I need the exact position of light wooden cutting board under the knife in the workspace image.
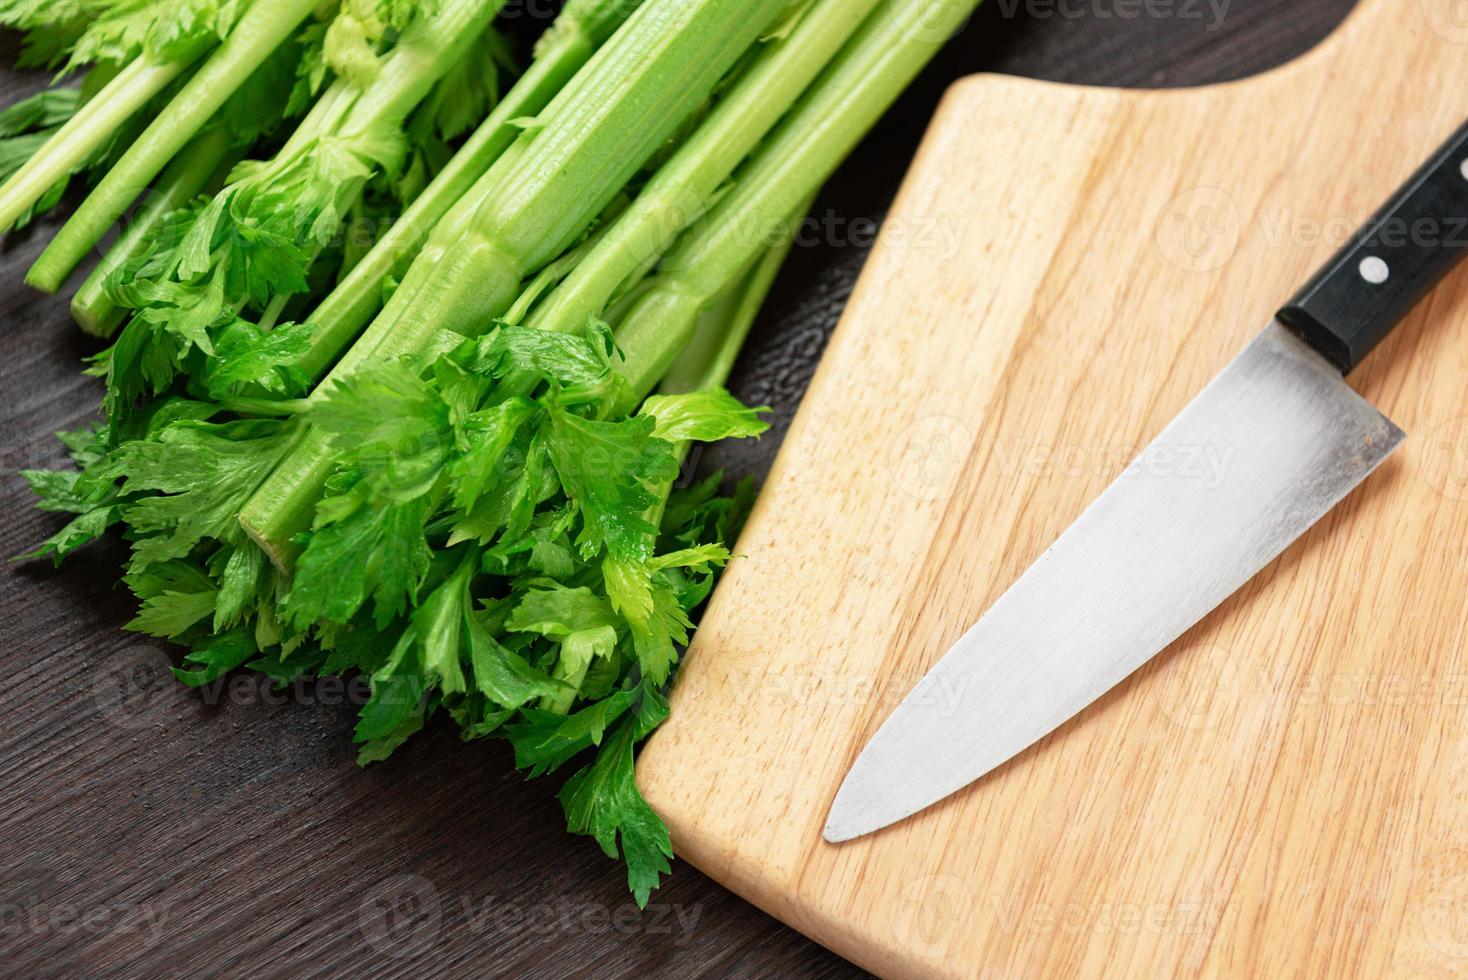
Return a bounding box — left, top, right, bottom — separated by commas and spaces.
639, 0, 1468, 979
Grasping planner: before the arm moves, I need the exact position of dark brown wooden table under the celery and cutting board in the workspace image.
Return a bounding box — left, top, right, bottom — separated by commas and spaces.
0, 0, 1351, 977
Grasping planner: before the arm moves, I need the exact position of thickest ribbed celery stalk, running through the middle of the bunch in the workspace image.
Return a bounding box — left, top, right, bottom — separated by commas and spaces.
239, 0, 787, 568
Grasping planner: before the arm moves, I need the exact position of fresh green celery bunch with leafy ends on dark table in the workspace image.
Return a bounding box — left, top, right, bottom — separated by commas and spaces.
17, 0, 976, 902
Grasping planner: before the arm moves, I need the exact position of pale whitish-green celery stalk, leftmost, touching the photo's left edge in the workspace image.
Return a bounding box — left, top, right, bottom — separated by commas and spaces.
0, 54, 204, 229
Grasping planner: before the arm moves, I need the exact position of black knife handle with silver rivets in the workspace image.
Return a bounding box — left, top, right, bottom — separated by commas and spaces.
1279, 115, 1468, 373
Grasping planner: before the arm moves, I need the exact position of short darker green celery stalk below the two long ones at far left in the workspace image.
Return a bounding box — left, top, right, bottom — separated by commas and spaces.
72, 126, 242, 337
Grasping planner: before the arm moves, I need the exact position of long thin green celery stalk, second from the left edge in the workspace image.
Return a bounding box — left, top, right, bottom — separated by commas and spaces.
25, 0, 316, 292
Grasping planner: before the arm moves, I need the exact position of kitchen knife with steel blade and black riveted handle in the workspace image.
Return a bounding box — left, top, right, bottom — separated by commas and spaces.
825, 125, 1468, 842
